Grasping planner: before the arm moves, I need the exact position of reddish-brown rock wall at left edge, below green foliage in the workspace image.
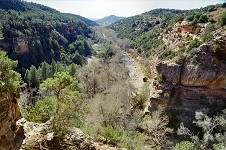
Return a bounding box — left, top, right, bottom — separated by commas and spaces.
0, 95, 20, 150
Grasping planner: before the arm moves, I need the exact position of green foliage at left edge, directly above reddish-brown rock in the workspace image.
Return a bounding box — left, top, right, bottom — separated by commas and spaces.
0, 51, 21, 97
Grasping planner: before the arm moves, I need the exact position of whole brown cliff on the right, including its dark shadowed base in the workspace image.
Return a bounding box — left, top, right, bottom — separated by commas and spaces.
149, 45, 226, 125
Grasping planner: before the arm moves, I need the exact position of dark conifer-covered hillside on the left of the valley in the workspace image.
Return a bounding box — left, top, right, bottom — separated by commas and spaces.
0, 0, 94, 71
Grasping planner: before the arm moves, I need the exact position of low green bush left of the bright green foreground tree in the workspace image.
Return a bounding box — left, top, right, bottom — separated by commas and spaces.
24, 97, 56, 123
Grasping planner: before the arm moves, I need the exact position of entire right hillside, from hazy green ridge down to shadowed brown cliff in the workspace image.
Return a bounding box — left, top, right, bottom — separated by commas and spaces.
108, 5, 226, 128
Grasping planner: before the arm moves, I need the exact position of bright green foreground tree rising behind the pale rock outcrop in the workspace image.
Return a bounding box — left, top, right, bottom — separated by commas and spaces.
40, 72, 82, 135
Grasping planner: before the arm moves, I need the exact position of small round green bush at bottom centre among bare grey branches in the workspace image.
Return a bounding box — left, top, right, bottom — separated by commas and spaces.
102, 126, 121, 145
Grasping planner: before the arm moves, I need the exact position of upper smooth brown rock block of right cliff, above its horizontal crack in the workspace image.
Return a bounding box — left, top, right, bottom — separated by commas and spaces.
156, 46, 226, 89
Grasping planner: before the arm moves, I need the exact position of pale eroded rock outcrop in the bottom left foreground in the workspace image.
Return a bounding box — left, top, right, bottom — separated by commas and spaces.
17, 118, 117, 150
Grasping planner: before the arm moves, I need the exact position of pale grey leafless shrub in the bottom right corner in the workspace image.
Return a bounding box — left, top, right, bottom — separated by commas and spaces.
177, 110, 226, 149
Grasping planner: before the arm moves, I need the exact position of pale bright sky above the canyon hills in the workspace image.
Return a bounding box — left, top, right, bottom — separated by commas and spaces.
25, 0, 226, 18
